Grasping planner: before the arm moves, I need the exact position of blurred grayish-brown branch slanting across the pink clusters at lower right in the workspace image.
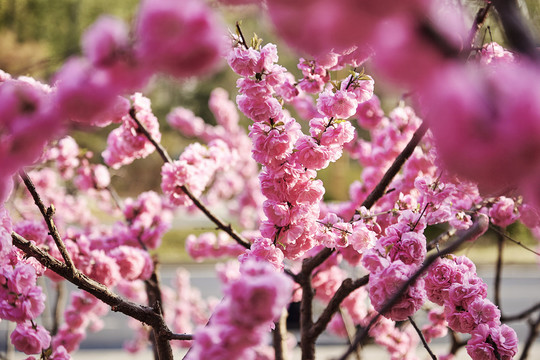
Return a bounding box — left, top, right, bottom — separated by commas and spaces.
340, 214, 489, 360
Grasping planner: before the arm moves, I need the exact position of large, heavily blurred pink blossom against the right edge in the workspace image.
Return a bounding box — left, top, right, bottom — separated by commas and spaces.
421, 62, 540, 192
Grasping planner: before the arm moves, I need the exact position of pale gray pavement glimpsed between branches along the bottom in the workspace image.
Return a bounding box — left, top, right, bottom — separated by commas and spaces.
0, 264, 540, 360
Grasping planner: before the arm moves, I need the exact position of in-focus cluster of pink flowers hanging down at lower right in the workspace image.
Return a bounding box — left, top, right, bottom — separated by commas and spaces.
425, 256, 517, 359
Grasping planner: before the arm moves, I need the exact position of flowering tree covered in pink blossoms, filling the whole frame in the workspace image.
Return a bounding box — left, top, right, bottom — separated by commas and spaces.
0, 0, 540, 360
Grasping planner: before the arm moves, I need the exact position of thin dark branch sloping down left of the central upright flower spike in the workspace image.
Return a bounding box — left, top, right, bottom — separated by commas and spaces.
129, 108, 251, 249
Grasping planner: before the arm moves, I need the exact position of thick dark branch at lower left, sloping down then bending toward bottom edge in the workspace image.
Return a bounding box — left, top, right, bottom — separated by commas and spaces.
11, 232, 178, 360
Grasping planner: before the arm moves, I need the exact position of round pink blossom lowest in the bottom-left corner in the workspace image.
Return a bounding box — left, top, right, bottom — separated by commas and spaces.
10, 321, 51, 355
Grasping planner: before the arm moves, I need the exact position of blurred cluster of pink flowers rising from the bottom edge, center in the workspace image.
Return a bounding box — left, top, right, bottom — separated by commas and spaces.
188, 261, 292, 359
